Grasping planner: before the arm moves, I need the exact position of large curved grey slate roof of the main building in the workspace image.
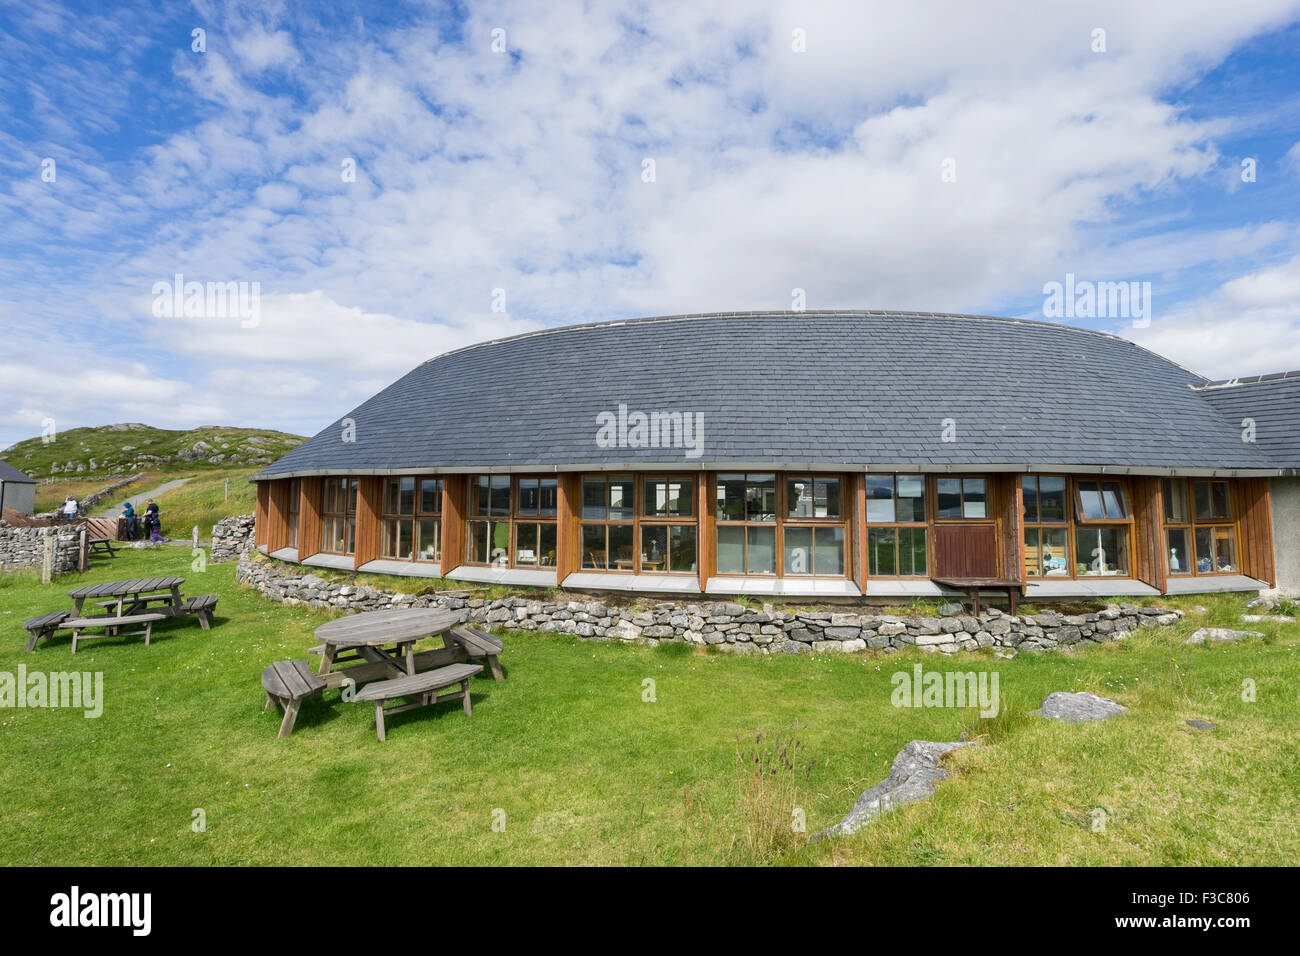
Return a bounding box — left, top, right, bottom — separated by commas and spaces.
255, 312, 1277, 479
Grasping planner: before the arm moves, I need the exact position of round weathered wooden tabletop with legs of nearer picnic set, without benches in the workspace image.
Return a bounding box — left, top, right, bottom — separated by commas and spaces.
316, 607, 460, 687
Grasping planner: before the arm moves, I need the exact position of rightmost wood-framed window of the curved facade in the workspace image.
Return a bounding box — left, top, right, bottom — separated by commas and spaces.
1161, 477, 1238, 575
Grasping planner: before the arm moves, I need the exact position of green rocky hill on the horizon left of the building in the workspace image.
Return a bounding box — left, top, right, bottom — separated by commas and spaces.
0, 421, 304, 480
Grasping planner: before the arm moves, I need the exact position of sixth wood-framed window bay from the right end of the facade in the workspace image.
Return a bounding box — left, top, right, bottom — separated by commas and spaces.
465, 475, 559, 568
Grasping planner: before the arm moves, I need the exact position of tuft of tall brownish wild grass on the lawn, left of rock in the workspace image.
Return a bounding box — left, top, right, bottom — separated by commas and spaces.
736, 721, 813, 864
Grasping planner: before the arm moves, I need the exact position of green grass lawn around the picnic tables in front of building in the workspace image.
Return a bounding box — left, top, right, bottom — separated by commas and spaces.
0, 549, 1300, 865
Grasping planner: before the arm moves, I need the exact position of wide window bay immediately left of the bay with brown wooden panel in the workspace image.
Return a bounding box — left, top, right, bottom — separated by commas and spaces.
718, 472, 846, 578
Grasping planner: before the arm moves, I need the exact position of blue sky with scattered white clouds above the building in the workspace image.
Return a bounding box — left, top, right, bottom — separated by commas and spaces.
0, 0, 1300, 447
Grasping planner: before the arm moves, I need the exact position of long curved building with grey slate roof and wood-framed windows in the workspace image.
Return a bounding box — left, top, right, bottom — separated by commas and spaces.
254, 312, 1295, 598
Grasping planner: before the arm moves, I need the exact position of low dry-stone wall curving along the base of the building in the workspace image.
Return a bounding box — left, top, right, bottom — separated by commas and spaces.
235, 554, 1183, 654
